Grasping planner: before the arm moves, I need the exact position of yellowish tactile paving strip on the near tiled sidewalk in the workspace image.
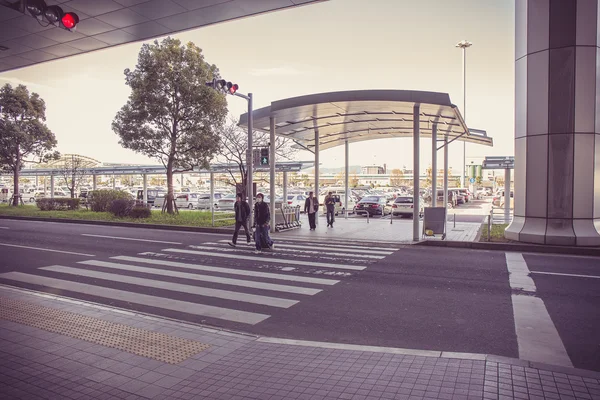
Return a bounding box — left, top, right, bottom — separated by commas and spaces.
0, 297, 210, 364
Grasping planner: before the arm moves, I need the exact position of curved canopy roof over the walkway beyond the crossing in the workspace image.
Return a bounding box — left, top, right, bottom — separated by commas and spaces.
240, 90, 493, 150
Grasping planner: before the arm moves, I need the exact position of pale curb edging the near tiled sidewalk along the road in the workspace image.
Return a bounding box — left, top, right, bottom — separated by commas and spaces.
0, 284, 600, 380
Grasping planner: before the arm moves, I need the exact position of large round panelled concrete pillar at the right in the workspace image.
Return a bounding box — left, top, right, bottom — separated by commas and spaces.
505, 0, 600, 246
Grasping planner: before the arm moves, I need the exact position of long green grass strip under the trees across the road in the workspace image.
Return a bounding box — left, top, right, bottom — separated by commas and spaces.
0, 204, 235, 228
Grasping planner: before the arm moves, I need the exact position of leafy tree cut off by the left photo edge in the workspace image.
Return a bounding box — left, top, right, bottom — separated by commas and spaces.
0, 83, 58, 206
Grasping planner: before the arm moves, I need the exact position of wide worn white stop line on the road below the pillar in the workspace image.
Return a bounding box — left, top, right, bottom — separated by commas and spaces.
506, 253, 573, 367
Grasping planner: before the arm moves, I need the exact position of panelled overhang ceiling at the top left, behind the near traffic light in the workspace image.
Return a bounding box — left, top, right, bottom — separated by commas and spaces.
0, 0, 327, 72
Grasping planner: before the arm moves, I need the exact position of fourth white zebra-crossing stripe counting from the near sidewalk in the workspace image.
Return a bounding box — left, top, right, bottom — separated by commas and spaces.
111, 256, 340, 285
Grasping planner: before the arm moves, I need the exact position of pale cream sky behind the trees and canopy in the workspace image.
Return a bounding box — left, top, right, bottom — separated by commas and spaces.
0, 0, 514, 175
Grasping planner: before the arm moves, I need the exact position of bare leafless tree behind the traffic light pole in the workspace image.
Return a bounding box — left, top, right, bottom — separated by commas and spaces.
217, 119, 297, 197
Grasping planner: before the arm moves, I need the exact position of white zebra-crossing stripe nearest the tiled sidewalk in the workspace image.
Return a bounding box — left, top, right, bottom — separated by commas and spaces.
0, 272, 270, 325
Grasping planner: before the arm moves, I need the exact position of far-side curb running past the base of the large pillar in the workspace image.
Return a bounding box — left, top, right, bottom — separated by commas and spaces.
413, 240, 600, 257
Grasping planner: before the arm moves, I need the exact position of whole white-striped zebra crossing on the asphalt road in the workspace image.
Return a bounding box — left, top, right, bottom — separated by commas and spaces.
0, 240, 397, 325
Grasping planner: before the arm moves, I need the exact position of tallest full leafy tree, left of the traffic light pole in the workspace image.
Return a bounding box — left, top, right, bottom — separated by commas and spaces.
112, 37, 227, 214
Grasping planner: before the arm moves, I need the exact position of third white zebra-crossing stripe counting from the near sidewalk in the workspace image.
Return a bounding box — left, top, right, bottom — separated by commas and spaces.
78, 260, 321, 296
